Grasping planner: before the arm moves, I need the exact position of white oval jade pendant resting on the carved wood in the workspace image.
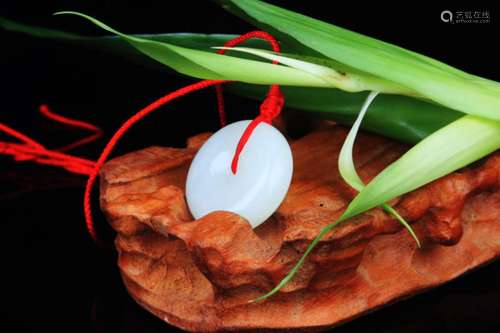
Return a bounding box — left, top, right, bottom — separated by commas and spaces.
186, 120, 293, 228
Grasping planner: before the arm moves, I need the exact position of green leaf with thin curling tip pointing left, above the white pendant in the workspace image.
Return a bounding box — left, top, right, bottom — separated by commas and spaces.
57, 11, 436, 94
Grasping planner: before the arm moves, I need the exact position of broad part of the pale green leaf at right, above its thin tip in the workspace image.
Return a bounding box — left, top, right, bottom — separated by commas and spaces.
349, 115, 500, 216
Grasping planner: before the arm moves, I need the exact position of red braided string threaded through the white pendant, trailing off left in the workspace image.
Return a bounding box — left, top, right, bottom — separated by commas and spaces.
0, 31, 284, 243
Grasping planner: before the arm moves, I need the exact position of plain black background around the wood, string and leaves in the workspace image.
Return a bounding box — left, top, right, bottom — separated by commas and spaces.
0, 0, 500, 333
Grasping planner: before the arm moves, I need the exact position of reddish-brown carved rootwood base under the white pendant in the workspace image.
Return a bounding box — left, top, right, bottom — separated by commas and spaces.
101, 126, 500, 332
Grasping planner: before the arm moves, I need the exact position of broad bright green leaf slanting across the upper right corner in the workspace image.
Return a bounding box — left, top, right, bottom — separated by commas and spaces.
218, 0, 500, 120
